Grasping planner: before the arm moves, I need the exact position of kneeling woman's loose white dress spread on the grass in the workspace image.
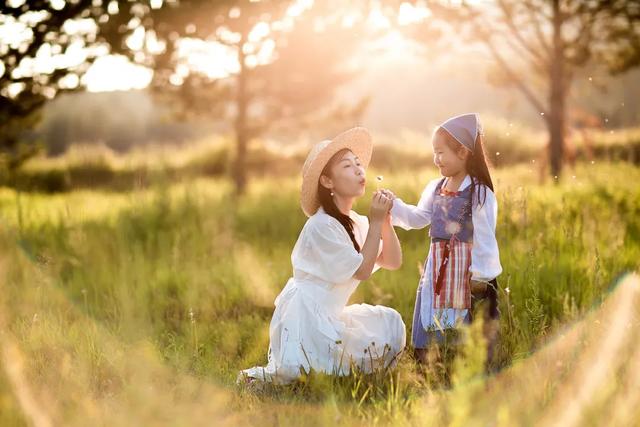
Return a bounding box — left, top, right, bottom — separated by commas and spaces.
241, 208, 406, 383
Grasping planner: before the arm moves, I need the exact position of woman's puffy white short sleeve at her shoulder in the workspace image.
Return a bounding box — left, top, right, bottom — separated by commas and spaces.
292, 218, 363, 283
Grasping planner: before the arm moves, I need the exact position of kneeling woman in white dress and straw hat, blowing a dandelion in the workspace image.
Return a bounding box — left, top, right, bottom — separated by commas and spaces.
240, 128, 405, 383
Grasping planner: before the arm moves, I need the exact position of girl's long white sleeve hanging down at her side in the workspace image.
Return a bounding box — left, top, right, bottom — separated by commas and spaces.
470, 187, 502, 281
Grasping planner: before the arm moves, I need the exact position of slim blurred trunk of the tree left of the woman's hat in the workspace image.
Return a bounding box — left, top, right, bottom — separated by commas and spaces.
233, 37, 249, 196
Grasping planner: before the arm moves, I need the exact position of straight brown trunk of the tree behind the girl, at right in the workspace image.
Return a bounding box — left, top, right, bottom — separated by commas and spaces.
547, 0, 567, 179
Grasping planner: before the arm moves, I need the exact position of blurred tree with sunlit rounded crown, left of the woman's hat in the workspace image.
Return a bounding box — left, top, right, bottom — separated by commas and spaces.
129, 0, 364, 194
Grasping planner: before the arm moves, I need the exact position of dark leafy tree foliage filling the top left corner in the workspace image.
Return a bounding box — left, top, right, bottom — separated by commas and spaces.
0, 0, 168, 171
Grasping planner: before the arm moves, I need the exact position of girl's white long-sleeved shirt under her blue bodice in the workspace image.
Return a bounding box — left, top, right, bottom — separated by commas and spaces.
391, 175, 502, 280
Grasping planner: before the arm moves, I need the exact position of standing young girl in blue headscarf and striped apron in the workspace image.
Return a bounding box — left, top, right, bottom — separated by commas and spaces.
389, 114, 502, 363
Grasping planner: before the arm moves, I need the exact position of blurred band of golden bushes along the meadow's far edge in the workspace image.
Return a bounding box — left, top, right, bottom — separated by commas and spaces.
7, 121, 640, 194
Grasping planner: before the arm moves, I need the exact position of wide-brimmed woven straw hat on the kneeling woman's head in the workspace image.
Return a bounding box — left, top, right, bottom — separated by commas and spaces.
300, 127, 373, 216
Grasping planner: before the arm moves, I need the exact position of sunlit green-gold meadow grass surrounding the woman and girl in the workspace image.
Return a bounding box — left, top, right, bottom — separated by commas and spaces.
0, 162, 640, 425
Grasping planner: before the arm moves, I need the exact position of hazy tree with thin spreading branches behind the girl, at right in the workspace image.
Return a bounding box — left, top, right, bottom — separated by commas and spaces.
418, 0, 640, 177
